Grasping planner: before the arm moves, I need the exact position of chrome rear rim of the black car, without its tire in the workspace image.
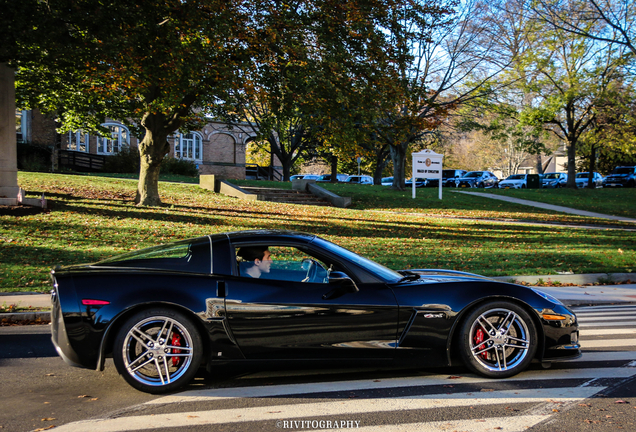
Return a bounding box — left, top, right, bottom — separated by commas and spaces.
122, 316, 194, 386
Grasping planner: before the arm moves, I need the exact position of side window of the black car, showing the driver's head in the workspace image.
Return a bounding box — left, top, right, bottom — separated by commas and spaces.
236, 245, 329, 283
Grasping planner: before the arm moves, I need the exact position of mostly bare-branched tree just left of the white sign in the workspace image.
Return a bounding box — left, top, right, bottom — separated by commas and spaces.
368, 1, 506, 189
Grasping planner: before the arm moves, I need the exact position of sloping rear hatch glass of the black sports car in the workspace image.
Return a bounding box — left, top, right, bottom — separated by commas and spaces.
94, 237, 212, 274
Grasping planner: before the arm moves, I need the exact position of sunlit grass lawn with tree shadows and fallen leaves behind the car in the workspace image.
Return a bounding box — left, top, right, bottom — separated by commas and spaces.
0, 172, 636, 291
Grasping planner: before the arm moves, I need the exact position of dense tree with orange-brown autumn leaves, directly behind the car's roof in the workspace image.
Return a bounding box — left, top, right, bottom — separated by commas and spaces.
220, 0, 393, 179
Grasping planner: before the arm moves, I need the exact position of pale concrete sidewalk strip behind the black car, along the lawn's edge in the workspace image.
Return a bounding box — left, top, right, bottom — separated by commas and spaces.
0, 273, 636, 323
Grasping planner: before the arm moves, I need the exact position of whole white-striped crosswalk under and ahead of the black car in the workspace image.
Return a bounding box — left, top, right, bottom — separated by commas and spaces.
55, 306, 636, 432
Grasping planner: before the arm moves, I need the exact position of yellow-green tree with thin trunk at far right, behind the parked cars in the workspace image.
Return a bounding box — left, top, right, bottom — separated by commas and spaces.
522, 6, 622, 188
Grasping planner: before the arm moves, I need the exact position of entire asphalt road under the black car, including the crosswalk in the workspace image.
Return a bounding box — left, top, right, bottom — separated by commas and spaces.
0, 306, 636, 432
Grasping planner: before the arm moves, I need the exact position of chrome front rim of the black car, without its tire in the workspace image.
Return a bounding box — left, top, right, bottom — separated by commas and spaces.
469, 308, 530, 371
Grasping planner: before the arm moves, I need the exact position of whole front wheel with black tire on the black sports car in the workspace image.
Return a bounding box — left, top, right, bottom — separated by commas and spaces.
459, 301, 538, 378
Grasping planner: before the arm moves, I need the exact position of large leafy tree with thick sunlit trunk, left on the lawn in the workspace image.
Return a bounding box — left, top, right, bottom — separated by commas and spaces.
11, 0, 250, 205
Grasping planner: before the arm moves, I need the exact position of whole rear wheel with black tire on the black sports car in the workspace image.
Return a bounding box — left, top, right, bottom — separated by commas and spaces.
113, 307, 203, 393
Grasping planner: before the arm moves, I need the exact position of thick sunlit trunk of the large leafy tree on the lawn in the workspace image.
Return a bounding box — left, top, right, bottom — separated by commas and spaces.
135, 114, 170, 206
